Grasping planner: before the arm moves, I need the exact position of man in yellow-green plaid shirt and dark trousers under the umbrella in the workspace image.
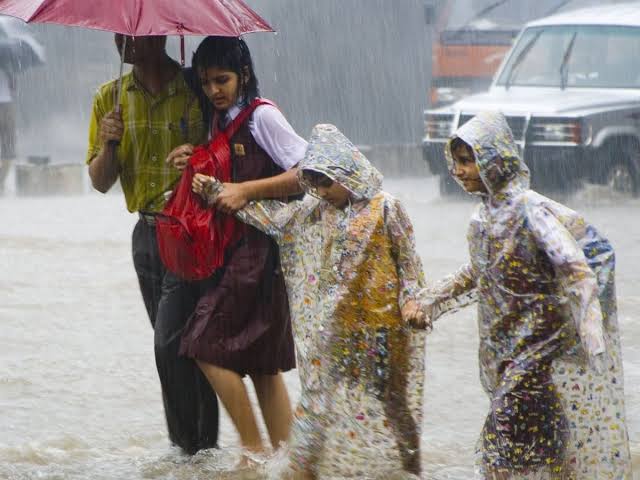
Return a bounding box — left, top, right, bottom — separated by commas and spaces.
87, 34, 218, 454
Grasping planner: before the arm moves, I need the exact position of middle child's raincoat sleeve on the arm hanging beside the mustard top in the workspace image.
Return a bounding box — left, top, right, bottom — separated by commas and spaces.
385, 199, 425, 308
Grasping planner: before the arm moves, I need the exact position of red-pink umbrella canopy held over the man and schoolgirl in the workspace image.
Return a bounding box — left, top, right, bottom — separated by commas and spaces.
0, 0, 273, 37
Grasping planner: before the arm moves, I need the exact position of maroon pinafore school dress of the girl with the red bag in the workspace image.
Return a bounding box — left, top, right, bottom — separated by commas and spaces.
180, 122, 295, 375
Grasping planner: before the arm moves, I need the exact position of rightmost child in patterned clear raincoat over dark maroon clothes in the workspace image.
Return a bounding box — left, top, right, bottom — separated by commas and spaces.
426, 113, 631, 480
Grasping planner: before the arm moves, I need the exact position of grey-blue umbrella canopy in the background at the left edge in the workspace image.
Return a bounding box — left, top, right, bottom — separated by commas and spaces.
0, 16, 45, 72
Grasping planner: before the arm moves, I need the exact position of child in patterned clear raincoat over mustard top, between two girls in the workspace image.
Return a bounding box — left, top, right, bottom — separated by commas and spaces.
194, 125, 424, 479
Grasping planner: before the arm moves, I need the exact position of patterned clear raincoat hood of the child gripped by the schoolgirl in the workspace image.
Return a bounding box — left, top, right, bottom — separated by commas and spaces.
298, 124, 383, 200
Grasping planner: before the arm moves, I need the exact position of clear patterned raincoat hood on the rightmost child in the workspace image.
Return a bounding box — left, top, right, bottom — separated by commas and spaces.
445, 112, 529, 197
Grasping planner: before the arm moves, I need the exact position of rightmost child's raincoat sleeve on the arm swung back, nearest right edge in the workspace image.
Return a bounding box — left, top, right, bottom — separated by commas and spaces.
527, 206, 605, 362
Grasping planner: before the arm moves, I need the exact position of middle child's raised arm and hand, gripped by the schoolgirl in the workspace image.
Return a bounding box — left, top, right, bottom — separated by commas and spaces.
192, 173, 318, 242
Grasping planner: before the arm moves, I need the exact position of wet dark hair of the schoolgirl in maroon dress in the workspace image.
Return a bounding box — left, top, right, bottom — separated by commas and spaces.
191, 36, 260, 112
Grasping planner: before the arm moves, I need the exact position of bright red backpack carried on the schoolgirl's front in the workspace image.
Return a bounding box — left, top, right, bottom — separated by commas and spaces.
156, 98, 275, 281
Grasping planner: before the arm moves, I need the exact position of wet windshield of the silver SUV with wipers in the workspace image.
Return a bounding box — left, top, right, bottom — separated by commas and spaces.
497, 26, 640, 88
